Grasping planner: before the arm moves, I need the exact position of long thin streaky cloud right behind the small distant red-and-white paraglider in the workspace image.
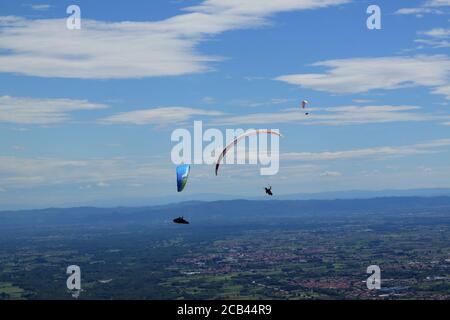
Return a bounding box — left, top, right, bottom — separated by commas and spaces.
213, 105, 450, 125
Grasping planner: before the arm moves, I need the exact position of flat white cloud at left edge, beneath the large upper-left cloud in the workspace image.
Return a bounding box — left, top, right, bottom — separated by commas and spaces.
0, 96, 107, 124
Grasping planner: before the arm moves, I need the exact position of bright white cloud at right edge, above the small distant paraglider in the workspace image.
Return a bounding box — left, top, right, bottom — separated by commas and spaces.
276, 55, 450, 99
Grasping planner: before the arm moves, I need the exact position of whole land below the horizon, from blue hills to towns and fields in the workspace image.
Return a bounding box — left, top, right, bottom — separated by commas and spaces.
0, 197, 450, 299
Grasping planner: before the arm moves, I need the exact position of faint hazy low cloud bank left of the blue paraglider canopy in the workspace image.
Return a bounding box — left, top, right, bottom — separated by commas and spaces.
0, 156, 172, 189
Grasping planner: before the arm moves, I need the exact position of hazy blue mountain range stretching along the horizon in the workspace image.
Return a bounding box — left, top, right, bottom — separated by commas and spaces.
0, 196, 450, 233
